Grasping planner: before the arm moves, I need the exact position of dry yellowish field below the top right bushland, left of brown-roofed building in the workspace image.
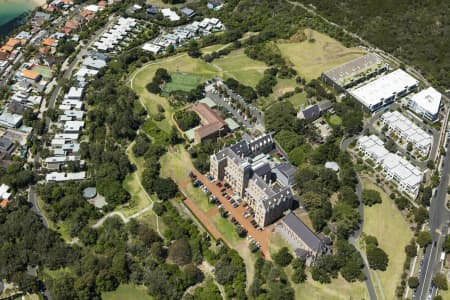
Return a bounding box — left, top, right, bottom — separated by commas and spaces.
277, 29, 364, 81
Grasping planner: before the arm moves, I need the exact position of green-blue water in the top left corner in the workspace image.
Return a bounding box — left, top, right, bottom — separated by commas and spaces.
0, 0, 37, 38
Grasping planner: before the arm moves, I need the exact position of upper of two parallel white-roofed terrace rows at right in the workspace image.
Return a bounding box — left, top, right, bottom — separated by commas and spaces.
380, 111, 433, 156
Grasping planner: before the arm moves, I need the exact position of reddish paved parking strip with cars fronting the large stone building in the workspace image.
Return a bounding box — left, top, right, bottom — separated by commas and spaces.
192, 171, 273, 257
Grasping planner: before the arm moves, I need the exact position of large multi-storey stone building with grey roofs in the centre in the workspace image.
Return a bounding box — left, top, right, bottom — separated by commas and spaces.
210, 134, 293, 227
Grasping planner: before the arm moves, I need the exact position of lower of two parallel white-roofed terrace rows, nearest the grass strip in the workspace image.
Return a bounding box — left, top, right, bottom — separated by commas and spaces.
357, 135, 423, 197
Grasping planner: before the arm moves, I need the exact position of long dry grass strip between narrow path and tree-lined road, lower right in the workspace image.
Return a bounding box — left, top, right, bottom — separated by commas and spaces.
363, 179, 413, 299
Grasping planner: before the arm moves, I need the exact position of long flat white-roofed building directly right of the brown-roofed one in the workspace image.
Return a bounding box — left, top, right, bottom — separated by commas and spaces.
350, 69, 419, 112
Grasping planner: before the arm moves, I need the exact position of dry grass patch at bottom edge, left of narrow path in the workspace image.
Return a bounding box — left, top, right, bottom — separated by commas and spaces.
286, 274, 370, 300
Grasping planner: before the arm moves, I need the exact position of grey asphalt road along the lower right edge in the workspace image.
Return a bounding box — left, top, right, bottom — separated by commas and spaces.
415, 151, 450, 300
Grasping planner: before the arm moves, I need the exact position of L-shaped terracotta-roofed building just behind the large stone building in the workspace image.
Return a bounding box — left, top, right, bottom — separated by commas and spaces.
192, 103, 229, 144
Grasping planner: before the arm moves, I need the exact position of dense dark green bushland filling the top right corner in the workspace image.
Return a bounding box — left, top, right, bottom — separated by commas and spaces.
297, 0, 450, 90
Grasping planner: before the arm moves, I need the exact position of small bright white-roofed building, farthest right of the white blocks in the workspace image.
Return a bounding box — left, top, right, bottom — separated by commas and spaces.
408, 87, 442, 122
